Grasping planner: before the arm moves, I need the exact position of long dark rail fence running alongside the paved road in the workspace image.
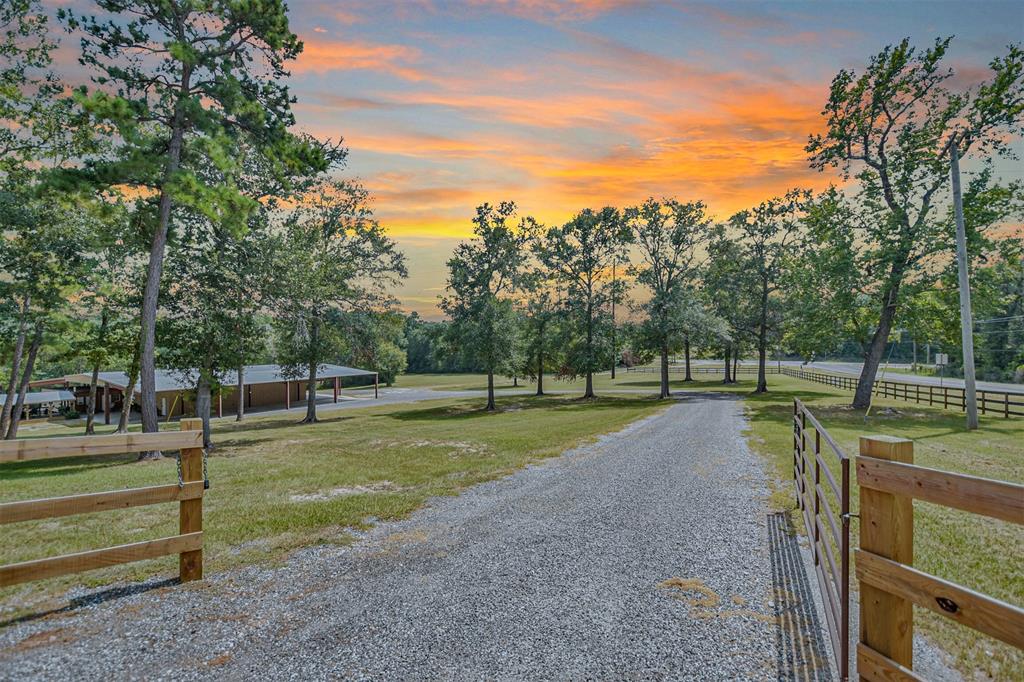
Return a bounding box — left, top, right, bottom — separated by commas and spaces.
782, 367, 1024, 419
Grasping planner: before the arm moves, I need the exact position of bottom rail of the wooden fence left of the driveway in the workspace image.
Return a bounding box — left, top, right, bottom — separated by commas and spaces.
0, 532, 203, 587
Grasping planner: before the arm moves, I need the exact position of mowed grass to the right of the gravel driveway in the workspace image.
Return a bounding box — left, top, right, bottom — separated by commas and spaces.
673, 376, 1024, 680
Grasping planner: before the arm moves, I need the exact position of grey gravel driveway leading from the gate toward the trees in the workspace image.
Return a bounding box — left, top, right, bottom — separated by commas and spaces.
0, 394, 829, 680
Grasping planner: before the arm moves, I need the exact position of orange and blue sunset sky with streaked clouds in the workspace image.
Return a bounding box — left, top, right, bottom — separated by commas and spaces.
50, 0, 1024, 316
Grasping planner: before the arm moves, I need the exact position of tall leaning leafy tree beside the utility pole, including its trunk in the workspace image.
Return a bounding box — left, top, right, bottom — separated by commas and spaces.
807, 38, 1024, 399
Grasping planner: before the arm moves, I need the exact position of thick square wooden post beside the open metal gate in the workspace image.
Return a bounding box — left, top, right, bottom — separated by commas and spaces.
858, 436, 913, 679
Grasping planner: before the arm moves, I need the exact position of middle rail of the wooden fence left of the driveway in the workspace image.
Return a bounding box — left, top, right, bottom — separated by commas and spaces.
0, 481, 203, 525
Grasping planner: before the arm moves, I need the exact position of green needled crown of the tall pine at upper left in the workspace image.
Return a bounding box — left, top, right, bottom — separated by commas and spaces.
58, 0, 327, 219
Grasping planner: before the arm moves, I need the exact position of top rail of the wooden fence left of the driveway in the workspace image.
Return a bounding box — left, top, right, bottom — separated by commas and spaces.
0, 431, 203, 463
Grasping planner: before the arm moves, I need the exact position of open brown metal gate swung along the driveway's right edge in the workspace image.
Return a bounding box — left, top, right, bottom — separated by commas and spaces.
793, 399, 850, 682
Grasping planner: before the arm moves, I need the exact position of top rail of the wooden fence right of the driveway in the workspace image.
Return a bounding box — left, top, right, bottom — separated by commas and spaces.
857, 457, 1024, 524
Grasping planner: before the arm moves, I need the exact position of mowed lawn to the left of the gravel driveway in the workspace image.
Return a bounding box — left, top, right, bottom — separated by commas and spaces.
0, 396, 664, 617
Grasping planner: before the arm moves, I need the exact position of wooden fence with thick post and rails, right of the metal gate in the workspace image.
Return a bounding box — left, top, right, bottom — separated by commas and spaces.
854, 436, 1024, 680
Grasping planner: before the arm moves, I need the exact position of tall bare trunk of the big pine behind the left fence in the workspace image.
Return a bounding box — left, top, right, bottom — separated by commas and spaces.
139, 65, 191, 446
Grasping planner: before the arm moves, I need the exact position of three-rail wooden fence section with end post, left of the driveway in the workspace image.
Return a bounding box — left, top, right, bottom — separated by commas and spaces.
0, 419, 205, 587
